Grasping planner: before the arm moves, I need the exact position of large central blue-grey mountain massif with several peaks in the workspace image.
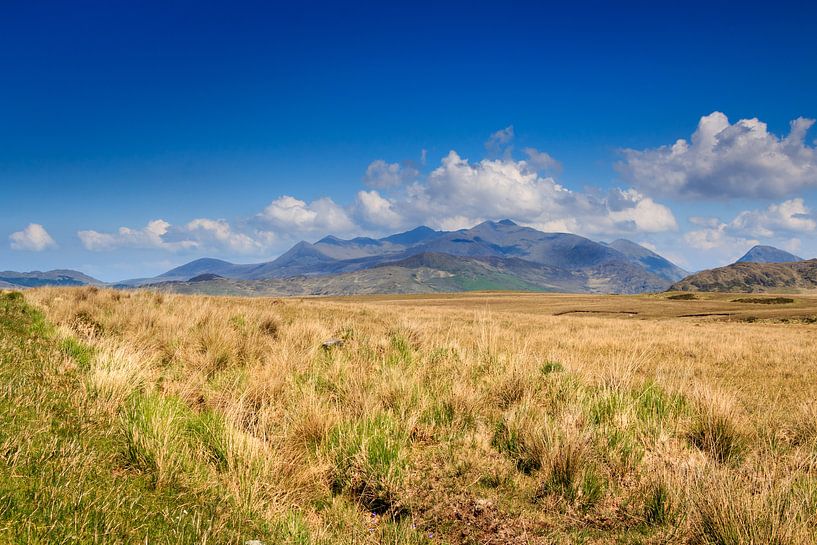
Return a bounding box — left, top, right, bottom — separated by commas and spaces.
132, 220, 686, 293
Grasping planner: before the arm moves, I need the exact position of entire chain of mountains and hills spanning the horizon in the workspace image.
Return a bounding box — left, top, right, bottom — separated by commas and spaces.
7, 220, 814, 295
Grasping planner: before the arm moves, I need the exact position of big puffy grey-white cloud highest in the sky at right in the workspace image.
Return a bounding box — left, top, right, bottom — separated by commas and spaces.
616, 112, 817, 198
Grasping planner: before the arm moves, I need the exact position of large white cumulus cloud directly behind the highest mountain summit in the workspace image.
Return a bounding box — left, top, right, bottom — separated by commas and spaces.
390, 151, 677, 234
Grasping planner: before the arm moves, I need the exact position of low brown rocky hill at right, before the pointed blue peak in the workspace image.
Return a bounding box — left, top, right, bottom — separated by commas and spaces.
670, 259, 817, 293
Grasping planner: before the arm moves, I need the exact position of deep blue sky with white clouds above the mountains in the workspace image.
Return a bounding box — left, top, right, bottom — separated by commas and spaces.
0, 1, 817, 280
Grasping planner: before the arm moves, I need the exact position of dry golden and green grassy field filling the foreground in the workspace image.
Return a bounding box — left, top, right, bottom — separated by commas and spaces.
0, 288, 817, 545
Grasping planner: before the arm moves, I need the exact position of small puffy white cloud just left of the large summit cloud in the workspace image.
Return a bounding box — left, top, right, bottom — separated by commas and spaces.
256, 195, 356, 235
